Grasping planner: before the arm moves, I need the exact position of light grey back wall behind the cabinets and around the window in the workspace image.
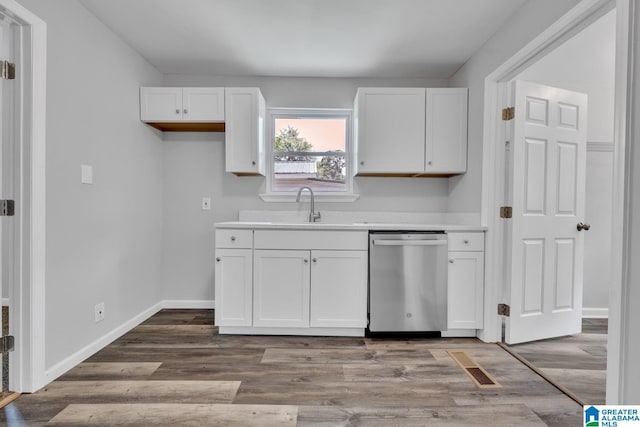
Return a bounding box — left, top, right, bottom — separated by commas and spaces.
162, 75, 448, 300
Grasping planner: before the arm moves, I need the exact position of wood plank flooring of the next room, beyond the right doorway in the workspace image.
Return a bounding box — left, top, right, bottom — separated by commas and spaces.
509, 319, 608, 405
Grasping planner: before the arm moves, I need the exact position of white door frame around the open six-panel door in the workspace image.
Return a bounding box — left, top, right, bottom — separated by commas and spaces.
478, 0, 634, 404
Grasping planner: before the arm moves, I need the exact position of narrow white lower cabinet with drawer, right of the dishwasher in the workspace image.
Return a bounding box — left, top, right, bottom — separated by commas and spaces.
447, 233, 484, 330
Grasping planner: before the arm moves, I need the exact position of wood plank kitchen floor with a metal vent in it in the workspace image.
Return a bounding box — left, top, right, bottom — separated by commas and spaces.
0, 310, 582, 426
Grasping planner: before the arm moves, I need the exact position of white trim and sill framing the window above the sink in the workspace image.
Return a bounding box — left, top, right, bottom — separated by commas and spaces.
260, 108, 360, 202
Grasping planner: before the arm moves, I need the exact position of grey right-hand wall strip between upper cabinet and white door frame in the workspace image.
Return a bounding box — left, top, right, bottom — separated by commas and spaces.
449, 0, 579, 212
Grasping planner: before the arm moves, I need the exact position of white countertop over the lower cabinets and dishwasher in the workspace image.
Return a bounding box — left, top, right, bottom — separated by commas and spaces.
215, 221, 487, 231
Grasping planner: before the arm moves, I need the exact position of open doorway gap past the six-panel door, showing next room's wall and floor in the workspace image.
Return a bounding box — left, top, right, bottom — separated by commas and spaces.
500, 10, 616, 404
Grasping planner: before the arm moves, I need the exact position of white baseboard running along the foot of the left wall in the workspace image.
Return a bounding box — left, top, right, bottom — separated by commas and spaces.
45, 301, 163, 383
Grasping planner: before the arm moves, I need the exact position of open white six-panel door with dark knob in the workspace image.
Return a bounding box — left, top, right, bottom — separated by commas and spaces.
505, 81, 587, 344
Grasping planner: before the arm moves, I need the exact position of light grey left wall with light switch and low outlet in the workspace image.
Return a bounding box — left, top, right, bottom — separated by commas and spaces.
20, 0, 163, 369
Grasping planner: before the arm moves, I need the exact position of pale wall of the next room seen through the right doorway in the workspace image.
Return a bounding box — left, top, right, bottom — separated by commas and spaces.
516, 10, 616, 315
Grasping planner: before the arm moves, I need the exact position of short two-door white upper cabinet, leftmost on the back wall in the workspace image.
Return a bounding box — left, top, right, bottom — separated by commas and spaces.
140, 87, 224, 123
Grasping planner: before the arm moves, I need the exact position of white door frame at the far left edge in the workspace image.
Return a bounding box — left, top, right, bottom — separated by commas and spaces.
0, 0, 47, 392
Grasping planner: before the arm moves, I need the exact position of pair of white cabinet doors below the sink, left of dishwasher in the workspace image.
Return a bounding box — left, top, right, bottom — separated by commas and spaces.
253, 250, 367, 328
